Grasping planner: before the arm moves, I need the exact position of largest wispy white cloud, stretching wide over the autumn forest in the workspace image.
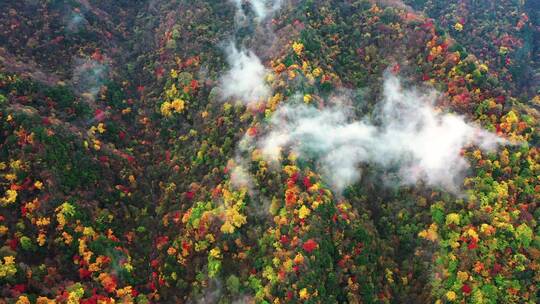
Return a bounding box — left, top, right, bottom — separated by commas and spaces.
257, 76, 504, 192
